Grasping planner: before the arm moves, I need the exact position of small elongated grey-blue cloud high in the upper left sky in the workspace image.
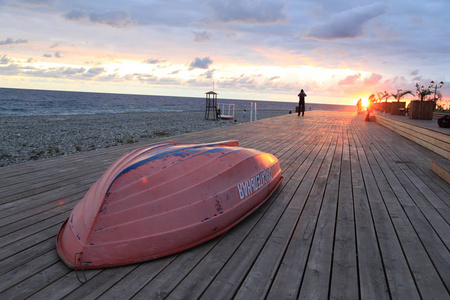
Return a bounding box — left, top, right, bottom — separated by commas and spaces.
64, 9, 133, 28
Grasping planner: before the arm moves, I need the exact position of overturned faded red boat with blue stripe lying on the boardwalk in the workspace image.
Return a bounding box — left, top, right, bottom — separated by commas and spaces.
57, 141, 282, 269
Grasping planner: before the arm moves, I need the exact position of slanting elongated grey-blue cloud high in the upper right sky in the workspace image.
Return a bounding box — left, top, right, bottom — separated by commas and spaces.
304, 2, 387, 40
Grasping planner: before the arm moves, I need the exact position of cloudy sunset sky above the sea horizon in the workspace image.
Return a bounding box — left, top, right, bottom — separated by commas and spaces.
0, 0, 450, 104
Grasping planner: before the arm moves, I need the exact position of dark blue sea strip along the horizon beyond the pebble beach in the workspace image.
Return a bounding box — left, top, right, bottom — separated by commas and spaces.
0, 88, 354, 117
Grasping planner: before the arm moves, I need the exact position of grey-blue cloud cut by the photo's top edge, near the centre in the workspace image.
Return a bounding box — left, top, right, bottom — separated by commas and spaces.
205, 0, 286, 25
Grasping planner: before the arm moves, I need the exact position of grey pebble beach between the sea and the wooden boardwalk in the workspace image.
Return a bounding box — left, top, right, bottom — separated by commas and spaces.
0, 110, 289, 167
